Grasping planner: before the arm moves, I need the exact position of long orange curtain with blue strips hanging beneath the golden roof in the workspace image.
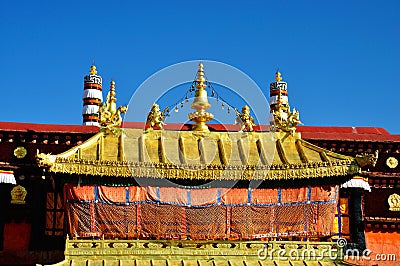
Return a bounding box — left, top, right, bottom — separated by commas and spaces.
64, 184, 338, 239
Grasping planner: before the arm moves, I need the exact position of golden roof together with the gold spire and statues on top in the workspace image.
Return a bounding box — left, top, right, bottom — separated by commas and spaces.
38, 63, 377, 187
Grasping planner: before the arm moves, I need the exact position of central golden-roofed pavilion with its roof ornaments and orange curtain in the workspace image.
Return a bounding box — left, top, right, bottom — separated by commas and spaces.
31, 63, 378, 265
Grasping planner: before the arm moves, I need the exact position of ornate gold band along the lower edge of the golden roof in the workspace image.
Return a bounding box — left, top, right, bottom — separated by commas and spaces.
49, 158, 359, 180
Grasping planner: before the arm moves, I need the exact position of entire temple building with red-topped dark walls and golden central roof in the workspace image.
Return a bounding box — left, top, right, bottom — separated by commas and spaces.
0, 63, 400, 266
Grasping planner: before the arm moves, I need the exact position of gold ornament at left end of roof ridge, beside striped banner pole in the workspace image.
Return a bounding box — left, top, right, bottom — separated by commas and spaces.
99, 81, 128, 130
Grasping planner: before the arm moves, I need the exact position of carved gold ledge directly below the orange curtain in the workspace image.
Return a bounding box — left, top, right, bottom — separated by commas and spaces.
65, 239, 342, 261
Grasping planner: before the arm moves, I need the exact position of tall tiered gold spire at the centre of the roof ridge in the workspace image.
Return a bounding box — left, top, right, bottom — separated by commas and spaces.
188, 62, 214, 131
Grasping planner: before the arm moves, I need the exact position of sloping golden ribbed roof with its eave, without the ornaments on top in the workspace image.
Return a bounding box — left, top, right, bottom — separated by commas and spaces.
38, 129, 360, 180
